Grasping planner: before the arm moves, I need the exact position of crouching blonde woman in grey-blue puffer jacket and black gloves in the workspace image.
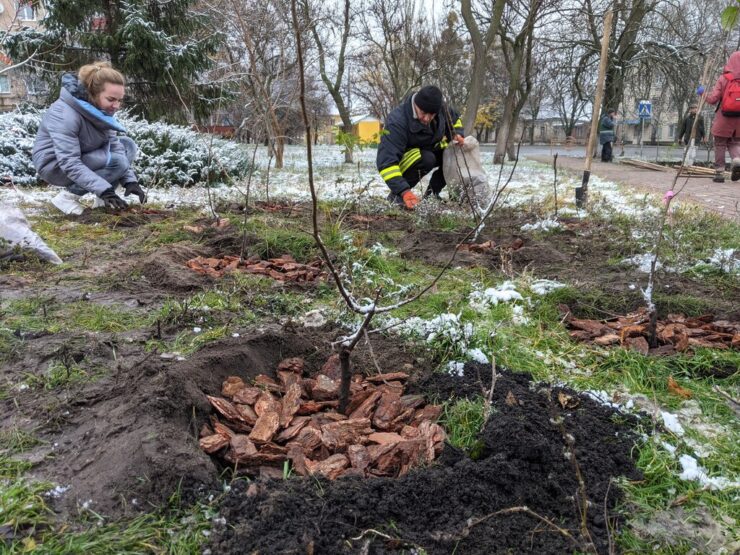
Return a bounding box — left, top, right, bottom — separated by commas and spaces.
32, 62, 146, 215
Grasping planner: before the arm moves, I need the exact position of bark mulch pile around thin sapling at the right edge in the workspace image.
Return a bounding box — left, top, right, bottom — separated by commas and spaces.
559, 305, 740, 355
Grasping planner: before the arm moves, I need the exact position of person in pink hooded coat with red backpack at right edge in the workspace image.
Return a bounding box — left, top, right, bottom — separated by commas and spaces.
696, 51, 740, 183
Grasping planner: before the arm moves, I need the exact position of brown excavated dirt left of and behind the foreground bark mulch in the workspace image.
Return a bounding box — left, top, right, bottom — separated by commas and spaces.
0, 327, 424, 517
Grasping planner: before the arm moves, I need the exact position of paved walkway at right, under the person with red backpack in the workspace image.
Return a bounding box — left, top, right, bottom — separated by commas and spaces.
526, 155, 740, 221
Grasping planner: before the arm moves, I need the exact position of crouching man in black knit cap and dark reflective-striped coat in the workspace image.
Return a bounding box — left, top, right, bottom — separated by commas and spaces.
376, 86, 464, 210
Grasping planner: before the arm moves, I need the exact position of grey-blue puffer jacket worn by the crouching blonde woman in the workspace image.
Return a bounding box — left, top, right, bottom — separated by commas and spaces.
33, 73, 136, 196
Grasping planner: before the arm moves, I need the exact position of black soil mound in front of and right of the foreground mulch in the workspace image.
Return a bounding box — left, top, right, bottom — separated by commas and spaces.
212, 365, 640, 554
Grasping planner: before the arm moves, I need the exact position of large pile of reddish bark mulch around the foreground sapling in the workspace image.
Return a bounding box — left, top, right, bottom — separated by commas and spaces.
200, 355, 446, 480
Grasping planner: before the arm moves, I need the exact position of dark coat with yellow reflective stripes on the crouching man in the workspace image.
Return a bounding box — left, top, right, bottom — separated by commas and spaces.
376, 95, 463, 195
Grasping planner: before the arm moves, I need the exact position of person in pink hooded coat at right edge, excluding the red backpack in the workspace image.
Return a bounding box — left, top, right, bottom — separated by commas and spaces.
697, 51, 740, 183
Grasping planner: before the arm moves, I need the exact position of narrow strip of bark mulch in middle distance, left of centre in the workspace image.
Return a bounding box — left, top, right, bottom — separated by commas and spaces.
185, 254, 326, 283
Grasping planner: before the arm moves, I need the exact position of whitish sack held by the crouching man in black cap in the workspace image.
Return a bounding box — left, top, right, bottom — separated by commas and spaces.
442, 136, 491, 211
